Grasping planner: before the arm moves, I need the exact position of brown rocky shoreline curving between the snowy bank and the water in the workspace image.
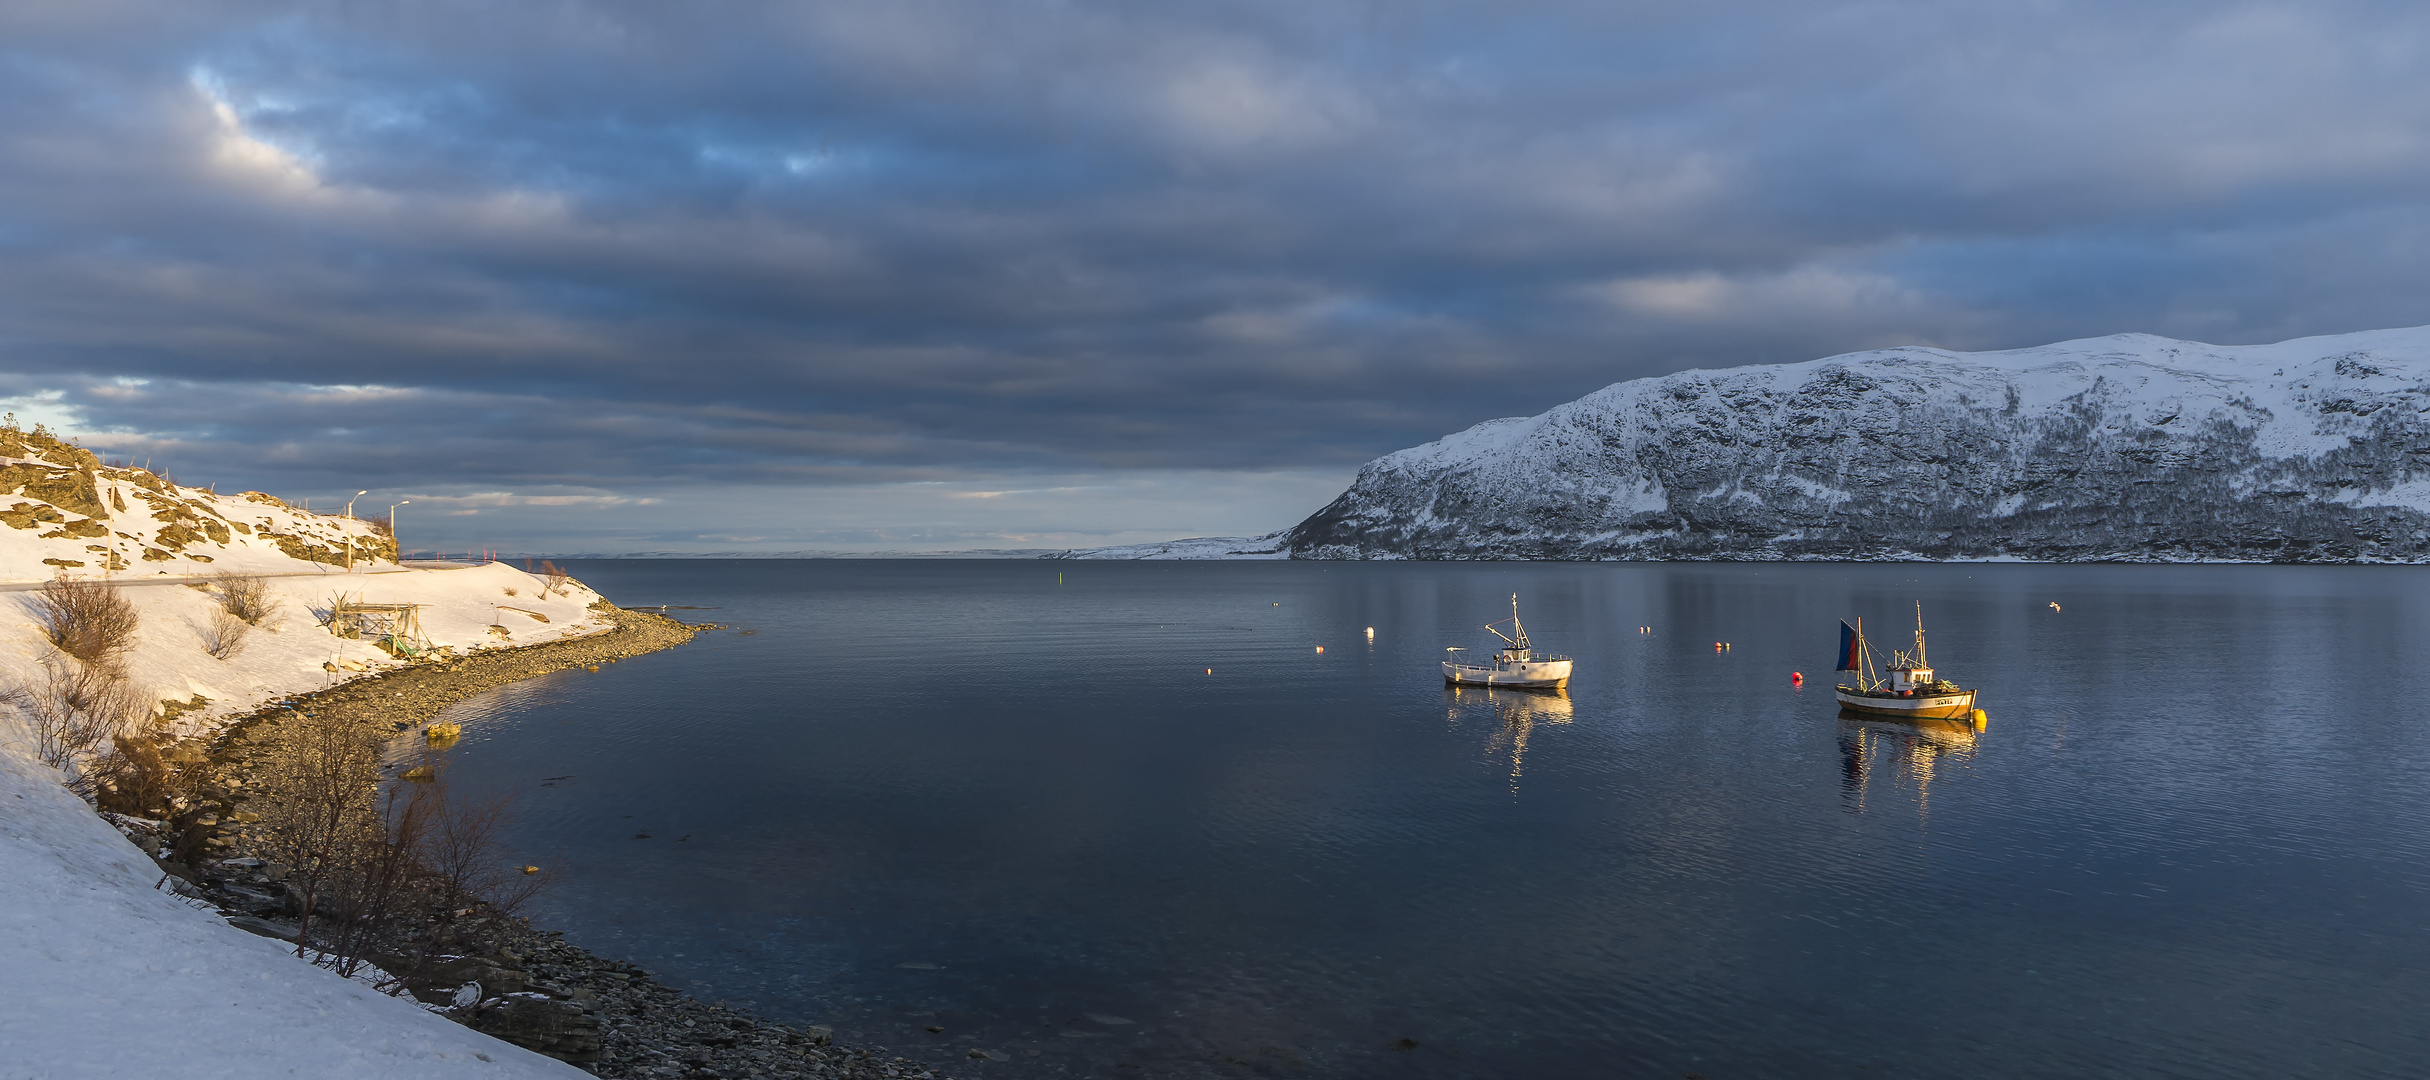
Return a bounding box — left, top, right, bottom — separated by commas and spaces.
104, 601, 936, 1080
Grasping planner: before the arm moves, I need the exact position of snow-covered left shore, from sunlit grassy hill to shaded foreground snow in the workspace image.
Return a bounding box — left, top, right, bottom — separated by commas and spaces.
0, 426, 612, 1078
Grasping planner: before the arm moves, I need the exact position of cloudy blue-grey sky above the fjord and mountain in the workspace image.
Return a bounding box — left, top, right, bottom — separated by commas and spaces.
0, 0, 2430, 555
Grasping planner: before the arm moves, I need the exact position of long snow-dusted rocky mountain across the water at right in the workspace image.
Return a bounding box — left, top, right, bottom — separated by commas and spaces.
1283, 328, 2430, 562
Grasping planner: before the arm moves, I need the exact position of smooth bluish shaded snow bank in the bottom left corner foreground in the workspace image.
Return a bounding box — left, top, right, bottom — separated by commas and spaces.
0, 725, 586, 1080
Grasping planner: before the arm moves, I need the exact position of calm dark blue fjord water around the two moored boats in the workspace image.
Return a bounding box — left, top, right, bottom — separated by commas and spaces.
437, 559, 2430, 1078
